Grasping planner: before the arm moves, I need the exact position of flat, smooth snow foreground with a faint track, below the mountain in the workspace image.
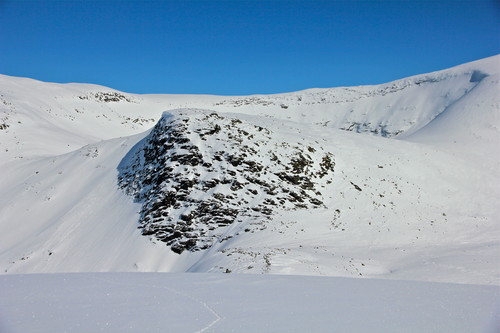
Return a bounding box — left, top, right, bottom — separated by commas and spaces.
0, 273, 500, 333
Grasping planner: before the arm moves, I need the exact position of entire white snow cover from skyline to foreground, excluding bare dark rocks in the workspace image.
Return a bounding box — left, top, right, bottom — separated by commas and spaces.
0, 56, 500, 333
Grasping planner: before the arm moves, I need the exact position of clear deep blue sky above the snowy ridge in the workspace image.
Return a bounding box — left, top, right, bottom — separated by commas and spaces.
0, 0, 500, 95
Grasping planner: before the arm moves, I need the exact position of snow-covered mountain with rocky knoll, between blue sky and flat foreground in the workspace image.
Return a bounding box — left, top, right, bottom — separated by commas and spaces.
0, 56, 500, 284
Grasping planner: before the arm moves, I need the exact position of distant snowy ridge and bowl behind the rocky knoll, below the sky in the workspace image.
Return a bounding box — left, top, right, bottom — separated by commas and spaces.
0, 56, 500, 158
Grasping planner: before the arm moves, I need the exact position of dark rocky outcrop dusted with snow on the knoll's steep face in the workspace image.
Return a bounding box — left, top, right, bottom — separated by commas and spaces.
118, 109, 335, 253
